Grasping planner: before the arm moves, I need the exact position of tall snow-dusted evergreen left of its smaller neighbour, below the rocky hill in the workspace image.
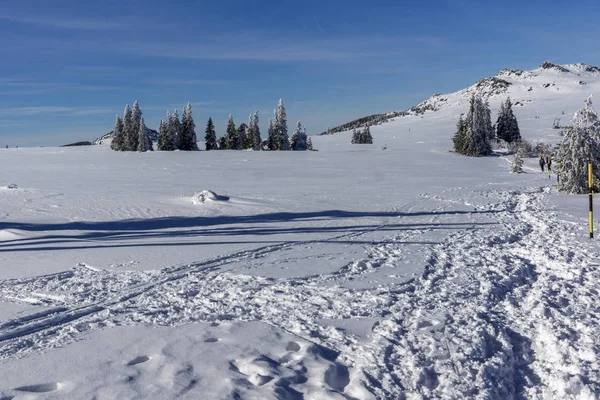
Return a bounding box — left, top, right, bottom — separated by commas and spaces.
455, 95, 492, 157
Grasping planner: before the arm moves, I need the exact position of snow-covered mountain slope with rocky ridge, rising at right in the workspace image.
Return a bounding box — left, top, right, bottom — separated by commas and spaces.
321, 62, 600, 135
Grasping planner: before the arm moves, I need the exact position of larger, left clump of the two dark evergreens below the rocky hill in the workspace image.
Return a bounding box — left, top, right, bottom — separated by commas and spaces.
453, 95, 494, 157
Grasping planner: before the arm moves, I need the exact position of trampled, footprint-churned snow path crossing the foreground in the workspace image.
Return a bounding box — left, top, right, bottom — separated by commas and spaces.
0, 188, 600, 399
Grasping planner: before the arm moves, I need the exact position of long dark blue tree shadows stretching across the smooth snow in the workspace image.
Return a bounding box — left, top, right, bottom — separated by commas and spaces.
0, 210, 497, 252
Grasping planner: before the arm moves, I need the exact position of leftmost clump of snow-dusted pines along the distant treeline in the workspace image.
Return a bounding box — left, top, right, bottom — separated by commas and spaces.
110, 101, 154, 152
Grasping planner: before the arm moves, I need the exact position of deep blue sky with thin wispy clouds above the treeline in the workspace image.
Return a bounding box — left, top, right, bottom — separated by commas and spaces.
0, 0, 600, 147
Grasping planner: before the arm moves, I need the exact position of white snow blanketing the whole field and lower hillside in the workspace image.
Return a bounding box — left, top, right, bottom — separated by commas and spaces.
0, 63, 600, 399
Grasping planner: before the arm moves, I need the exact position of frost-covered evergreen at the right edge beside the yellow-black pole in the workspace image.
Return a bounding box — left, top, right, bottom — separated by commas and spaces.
555, 96, 600, 193
